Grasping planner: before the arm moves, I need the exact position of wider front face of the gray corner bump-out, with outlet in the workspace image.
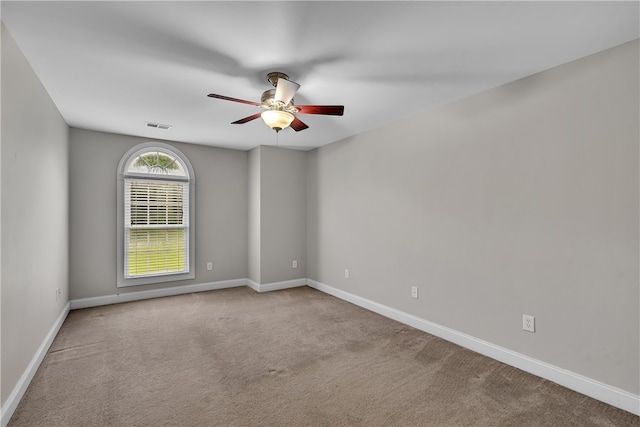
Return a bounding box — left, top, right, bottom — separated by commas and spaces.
260, 146, 307, 283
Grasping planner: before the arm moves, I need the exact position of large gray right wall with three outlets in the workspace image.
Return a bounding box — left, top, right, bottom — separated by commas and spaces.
307, 41, 640, 395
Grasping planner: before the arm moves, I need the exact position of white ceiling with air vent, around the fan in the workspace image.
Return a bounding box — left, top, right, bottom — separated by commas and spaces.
0, 1, 639, 150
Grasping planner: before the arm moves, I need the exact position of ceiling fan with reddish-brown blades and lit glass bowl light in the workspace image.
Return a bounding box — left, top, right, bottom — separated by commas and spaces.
207, 71, 344, 132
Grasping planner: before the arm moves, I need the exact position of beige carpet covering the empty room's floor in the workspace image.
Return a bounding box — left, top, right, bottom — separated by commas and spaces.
9, 287, 640, 427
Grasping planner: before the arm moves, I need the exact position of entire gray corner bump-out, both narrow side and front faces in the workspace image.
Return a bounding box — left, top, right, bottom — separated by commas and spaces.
249, 146, 307, 284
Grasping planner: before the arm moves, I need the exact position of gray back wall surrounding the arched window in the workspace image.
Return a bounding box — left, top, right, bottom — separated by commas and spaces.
69, 128, 248, 299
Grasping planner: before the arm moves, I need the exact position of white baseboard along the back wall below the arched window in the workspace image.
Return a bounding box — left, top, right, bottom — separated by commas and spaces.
71, 279, 247, 310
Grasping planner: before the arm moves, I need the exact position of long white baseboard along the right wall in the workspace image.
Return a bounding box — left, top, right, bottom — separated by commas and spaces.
307, 279, 640, 415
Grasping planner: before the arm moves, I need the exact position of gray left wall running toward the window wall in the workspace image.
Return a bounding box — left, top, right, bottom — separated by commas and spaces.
0, 24, 69, 405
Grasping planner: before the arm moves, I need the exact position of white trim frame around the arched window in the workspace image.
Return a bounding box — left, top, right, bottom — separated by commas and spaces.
116, 142, 196, 288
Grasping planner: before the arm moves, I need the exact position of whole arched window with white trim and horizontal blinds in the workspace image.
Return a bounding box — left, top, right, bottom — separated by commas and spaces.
117, 142, 195, 287
